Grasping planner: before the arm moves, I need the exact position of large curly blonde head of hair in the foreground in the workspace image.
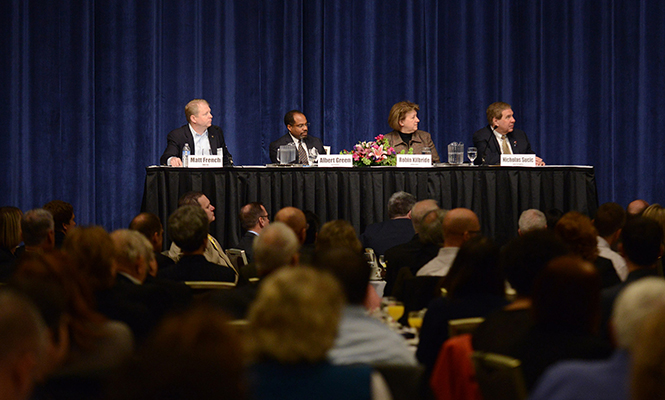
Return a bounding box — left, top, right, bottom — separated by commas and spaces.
248, 267, 344, 364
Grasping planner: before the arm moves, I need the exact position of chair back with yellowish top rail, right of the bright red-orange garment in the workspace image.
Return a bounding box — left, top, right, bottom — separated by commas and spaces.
471, 351, 527, 400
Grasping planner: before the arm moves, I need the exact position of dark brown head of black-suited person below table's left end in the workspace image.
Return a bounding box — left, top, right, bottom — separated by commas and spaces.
168, 205, 209, 252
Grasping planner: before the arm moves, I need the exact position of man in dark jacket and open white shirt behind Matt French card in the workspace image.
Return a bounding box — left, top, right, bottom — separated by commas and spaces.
159, 99, 233, 167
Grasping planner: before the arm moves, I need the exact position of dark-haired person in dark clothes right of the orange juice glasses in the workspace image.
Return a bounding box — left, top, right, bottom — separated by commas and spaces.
416, 236, 507, 373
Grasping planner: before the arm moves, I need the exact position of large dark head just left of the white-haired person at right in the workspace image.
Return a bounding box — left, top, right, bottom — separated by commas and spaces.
533, 256, 600, 334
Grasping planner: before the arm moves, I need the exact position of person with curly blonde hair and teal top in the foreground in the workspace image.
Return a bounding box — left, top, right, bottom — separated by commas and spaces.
247, 267, 390, 400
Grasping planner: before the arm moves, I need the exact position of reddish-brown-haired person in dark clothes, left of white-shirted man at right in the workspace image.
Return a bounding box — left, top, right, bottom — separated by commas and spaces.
554, 211, 621, 288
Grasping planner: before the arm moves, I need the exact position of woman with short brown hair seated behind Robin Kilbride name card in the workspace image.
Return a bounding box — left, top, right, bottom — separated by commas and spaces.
385, 101, 440, 163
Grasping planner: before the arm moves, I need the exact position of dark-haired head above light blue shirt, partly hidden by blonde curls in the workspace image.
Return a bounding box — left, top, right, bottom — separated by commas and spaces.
315, 248, 370, 305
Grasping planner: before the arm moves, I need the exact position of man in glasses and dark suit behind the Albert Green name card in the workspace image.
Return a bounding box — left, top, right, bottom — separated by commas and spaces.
270, 110, 326, 164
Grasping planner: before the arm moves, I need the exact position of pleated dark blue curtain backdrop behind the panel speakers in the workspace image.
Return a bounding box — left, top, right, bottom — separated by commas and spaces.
0, 0, 665, 229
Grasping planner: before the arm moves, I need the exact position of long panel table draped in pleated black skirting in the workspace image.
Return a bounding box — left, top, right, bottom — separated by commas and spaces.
141, 165, 598, 248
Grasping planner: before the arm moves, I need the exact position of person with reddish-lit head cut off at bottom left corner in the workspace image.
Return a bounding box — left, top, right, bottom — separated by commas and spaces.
0, 288, 47, 400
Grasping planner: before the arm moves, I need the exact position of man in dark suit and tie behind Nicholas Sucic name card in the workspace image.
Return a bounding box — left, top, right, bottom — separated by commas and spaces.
473, 102, 545, 165
